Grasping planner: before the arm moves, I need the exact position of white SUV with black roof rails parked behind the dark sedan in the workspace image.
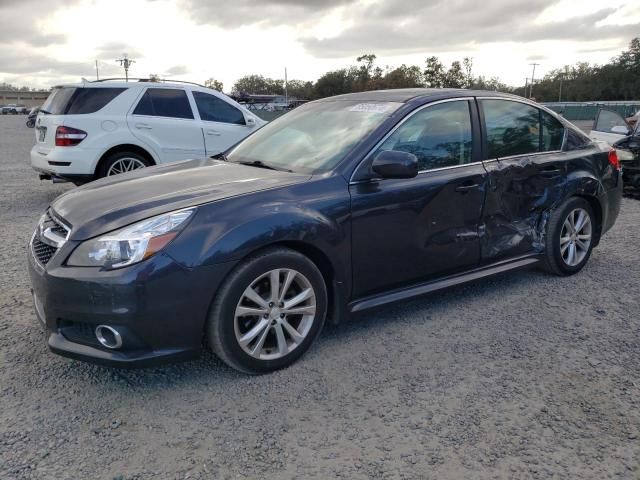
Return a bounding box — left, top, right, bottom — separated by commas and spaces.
31, 81, 265, 184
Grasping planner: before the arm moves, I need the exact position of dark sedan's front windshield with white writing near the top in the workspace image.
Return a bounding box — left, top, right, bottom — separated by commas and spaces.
227, 101, 401, 174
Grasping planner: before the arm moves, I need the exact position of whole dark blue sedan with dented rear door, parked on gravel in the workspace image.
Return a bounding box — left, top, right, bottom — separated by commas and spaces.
29, 89, 622, 374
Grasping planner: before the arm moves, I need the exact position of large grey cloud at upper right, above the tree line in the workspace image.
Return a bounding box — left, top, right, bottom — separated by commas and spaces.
302, 0, 640, 58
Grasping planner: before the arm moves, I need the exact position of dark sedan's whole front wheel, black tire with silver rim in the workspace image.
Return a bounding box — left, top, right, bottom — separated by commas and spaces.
206, 248, 327, 375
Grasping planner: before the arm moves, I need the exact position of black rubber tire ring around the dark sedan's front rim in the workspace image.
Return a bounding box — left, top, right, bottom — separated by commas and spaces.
208, 250, 327, 374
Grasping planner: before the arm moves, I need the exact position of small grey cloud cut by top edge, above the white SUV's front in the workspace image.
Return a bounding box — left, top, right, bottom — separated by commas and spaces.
180, 0, 357, 28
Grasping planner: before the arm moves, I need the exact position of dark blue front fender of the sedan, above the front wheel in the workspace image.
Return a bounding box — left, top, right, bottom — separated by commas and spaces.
167, 176, 351, 283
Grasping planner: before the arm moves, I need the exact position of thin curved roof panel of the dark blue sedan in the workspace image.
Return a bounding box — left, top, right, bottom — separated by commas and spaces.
317, 88, 521, 103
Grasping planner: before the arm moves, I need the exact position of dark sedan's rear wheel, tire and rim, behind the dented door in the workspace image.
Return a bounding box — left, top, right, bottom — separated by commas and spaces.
543, 197, 598, 276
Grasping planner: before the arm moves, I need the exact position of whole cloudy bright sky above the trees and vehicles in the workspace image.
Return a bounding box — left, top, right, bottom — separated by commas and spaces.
0, 0, 640, 92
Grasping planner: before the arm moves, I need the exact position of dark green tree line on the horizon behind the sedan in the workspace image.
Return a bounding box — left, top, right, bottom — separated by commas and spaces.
211, 38, 640, 102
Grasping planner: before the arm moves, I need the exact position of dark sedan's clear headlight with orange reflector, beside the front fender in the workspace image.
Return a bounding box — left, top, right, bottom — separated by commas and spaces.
67, 208, 195, 269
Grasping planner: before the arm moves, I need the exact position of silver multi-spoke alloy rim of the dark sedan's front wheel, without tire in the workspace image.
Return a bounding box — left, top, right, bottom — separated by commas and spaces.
234, 268, 316, 360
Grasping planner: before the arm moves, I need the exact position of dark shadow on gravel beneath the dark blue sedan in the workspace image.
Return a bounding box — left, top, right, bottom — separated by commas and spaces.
52, 269, 548, 393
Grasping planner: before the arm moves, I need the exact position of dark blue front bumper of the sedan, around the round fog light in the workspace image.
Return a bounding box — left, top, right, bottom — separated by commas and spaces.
28, 241, 236, 368
